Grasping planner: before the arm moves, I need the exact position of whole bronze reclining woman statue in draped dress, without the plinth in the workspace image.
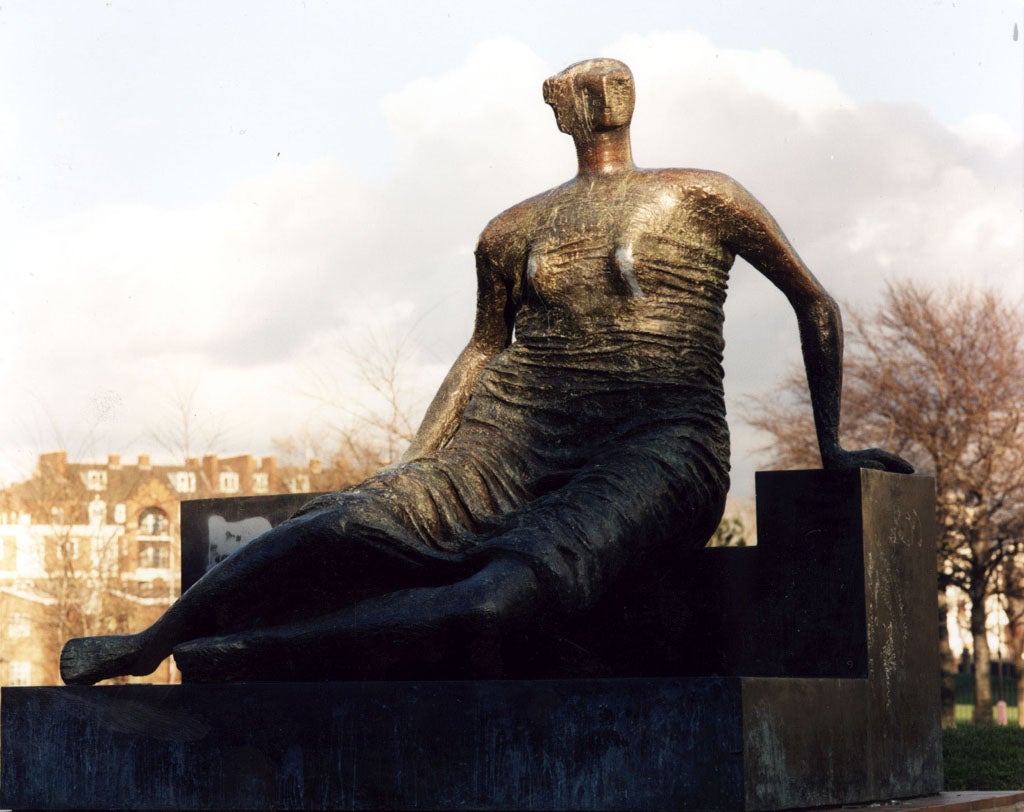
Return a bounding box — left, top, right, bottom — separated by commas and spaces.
60, 59, 910, 683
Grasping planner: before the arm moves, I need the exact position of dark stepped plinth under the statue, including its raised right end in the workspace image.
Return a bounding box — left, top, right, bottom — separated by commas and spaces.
0, 464, 942, 812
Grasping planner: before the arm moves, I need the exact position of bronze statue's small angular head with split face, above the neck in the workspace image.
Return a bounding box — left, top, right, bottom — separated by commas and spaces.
544, 58, 636, 136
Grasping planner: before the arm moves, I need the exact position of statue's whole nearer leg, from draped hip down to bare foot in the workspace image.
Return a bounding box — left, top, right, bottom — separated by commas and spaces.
174, 450, 723, 681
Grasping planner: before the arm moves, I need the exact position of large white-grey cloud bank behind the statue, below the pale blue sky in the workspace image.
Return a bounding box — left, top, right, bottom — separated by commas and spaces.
0, 34, 1024, 489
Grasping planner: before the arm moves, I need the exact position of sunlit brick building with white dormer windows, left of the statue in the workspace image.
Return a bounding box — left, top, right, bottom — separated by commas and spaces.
0, 452, 330, 685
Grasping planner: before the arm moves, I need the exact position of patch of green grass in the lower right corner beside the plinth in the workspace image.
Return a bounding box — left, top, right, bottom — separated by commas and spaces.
942, 725, 1024, 793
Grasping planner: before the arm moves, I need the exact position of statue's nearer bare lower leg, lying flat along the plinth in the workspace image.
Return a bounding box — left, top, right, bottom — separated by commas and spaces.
174, 558, 545, 682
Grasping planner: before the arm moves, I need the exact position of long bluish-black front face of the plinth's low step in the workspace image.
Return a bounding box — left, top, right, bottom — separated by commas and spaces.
0, 678, 743, 810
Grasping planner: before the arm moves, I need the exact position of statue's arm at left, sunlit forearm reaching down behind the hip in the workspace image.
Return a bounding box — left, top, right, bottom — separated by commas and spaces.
401, 241, 515, 462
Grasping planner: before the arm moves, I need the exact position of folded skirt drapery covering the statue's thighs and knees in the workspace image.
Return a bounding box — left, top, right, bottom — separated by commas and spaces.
286, 435, 728, 613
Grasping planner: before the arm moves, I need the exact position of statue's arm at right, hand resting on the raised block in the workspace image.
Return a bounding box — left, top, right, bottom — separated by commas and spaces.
719, 178, 913, 473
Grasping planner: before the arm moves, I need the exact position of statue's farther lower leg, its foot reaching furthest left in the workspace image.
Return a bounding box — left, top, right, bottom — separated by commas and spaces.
60, 508, 440, 684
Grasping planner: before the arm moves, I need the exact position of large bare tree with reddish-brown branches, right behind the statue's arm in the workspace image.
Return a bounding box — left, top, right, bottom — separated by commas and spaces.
748, 283, 1024, 724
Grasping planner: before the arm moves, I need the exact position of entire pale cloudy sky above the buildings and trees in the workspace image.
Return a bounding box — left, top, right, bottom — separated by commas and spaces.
0, 0, 1024, 497
